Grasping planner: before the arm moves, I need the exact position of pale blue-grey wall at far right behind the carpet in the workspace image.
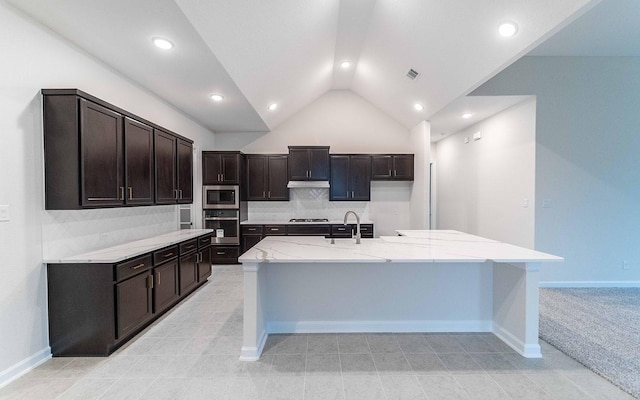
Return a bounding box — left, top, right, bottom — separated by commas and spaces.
473, 57, 640, 285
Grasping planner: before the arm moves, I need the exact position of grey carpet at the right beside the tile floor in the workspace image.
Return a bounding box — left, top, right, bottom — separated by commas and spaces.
540, 288, 640, 399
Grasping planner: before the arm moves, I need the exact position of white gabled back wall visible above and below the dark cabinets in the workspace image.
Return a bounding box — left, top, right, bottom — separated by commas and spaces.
216, 90, 420, 236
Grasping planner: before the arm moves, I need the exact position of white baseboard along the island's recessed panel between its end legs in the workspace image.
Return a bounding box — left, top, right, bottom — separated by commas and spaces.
267, 320, 493, 333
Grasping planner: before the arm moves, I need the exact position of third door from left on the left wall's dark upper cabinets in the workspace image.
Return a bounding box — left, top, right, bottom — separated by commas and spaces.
154, 130, 177, 204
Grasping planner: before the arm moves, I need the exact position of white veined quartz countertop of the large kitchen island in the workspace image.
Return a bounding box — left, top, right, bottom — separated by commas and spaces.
239, 231, 563, 263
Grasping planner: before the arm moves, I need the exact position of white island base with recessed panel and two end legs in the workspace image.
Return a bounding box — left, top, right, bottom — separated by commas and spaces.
240, 261, 541, 361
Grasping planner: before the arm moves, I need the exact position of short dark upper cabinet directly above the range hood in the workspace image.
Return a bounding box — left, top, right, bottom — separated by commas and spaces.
289, 146, 329, 181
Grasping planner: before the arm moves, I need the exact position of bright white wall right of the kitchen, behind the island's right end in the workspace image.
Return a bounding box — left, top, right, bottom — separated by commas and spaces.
436, 99, 536, 248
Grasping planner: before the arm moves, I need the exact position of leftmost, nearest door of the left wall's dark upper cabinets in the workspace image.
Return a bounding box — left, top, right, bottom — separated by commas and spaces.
79, 99, 124, 207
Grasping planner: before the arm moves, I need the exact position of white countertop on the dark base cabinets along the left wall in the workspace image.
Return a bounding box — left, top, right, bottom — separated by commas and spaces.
43, 229, 213, 264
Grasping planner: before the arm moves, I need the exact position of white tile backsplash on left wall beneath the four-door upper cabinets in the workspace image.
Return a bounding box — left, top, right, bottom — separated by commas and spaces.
42, 205, 178, 260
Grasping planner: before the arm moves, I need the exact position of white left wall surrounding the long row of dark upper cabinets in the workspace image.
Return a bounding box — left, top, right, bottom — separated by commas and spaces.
0, 2, 214, 385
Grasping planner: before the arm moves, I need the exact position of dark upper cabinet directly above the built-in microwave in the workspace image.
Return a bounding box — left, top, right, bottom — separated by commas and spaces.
202, 151, 243, 185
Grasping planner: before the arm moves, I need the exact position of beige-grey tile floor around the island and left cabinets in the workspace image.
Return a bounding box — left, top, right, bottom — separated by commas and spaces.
0, 266, 632, 400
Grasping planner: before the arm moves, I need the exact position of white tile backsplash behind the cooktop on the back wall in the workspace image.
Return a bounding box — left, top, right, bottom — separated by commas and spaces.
248, 188, 369, 222
